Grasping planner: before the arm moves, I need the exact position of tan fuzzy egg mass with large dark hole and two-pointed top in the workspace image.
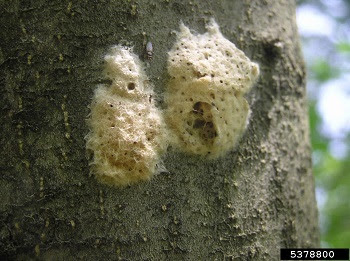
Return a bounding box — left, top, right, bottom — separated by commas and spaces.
165, 20, 259, 158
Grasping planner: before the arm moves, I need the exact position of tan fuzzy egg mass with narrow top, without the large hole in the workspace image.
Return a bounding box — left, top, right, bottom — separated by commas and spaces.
86, 46, 166, 186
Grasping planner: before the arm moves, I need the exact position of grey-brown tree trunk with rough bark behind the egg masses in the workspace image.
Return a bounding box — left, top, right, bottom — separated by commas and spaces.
0, 0, 319, 260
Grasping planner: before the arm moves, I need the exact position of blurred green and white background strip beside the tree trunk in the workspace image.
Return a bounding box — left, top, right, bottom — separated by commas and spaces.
297, 0, 350, 247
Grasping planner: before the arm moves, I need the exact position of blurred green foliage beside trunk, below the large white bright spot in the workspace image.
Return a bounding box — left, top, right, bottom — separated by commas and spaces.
309, 98, 350, 247
